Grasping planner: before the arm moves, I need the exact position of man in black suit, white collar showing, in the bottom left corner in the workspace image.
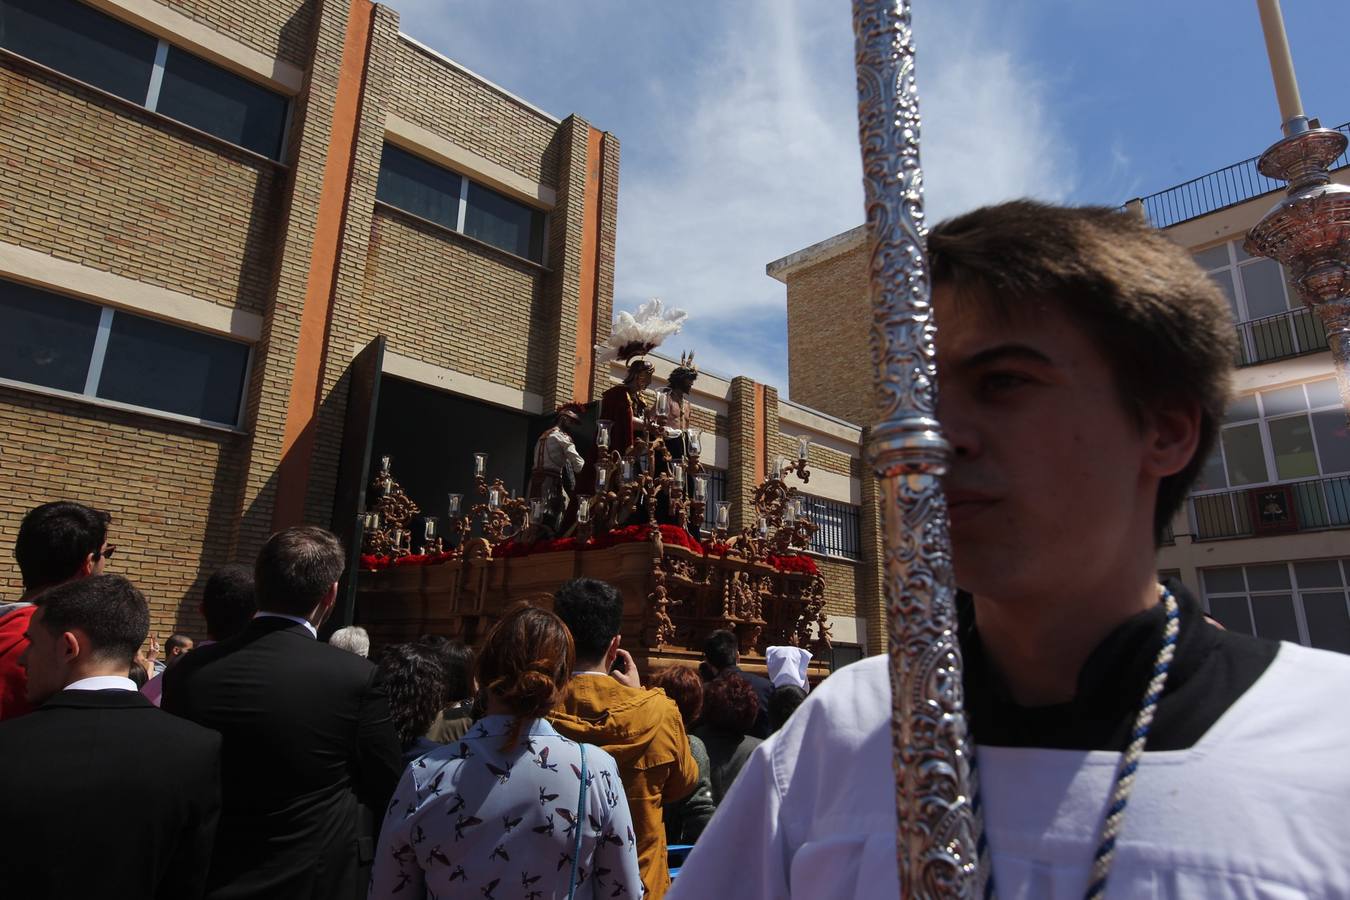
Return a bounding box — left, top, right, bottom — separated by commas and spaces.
0, 575, 220, 900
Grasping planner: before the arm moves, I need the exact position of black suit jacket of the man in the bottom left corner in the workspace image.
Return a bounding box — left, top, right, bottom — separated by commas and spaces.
0, 691, 220, 900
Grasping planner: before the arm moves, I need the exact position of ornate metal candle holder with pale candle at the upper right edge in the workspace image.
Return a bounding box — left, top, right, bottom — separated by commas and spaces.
1243, 0, 1350, 416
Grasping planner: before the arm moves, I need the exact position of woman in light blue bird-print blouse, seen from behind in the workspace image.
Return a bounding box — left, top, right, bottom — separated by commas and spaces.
370, 607, 643, 900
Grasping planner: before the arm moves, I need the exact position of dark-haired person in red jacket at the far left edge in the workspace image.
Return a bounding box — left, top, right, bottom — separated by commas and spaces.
0, 501, 116, 721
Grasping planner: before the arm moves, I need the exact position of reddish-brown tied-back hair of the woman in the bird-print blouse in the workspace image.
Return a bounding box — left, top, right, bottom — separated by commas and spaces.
478, 606, 576, 750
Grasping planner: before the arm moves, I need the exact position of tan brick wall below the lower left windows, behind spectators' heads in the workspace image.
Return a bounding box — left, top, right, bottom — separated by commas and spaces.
0, 387, 243, 638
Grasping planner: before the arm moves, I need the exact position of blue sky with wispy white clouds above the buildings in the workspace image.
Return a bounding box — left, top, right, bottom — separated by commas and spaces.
390, 0, 1350, 395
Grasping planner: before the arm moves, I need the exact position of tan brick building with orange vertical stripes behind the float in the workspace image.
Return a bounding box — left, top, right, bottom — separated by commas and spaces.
0, 0, 867, 661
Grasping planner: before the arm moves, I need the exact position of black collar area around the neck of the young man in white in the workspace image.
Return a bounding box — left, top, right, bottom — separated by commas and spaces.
959, 582, 1278, 752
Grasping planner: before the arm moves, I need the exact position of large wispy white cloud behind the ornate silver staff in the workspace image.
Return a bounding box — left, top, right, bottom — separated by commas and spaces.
616, 0, 1072, 394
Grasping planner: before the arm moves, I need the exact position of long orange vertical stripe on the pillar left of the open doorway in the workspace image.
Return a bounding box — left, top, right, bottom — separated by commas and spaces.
271, 0, 375, 529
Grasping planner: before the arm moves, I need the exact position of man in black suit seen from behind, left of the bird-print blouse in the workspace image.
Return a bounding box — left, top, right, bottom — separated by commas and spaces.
163, 528, 402, 900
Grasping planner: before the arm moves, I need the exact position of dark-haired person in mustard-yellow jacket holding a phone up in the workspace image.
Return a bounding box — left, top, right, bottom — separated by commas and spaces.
548, 578, 711, 900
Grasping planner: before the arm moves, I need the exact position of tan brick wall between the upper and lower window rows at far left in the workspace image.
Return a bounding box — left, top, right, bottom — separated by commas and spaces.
0, 59, 284, 313
